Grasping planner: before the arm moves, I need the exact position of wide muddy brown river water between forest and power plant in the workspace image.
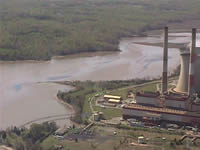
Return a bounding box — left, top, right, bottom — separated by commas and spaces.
0, 34, 189, 128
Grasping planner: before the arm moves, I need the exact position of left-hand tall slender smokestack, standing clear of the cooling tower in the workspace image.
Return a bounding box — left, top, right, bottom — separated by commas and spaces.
161, 27, 168, 94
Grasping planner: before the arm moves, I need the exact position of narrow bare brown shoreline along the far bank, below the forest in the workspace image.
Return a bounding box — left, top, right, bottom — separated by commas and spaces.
0, 19, 200, 64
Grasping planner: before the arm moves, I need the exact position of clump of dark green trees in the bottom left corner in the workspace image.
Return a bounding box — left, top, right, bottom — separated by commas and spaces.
0, 122, 57, 150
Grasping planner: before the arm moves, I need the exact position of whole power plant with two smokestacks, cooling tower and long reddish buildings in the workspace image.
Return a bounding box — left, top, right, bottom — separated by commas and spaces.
123, 27, 200, 126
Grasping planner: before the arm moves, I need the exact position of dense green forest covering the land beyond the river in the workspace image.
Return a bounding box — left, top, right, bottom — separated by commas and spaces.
0, 0, 200, 60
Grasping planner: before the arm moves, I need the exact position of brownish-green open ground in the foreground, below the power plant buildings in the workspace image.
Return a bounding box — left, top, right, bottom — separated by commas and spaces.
41, 126, 200, 150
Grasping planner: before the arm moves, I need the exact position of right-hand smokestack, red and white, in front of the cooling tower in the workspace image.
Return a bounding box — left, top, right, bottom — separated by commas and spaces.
188, 28, 196, 95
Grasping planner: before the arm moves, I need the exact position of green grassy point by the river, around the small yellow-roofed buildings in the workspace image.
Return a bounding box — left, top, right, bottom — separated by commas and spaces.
57, 79, 154, 123
